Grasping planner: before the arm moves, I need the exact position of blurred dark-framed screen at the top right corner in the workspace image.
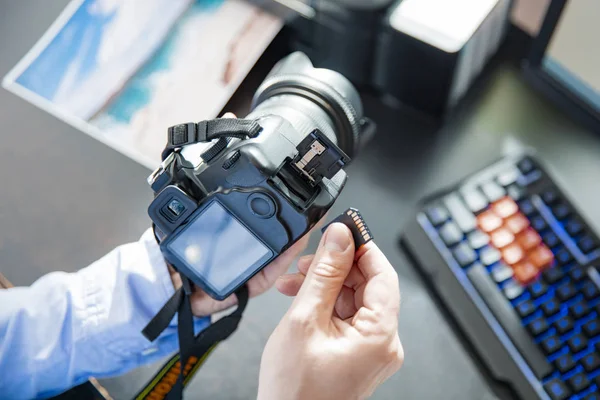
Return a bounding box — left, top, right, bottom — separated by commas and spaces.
524, 0, 600, 132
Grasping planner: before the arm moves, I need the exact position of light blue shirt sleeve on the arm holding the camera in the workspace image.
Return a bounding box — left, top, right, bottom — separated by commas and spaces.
0, 230, 210, 399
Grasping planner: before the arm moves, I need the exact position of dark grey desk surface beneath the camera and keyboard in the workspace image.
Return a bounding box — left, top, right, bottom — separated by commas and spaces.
0, 0, 600, 400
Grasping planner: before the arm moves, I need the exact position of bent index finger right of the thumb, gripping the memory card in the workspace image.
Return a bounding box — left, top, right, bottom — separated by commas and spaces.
355, 242, 400, 318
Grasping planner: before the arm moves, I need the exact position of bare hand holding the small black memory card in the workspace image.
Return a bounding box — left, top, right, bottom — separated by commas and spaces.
258, 223, 404, 400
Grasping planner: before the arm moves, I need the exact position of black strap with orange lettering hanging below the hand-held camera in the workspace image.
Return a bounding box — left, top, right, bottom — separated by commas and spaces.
135, 275, 248, 400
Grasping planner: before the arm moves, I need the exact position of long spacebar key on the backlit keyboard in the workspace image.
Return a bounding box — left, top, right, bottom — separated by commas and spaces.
467, 265, 552, 379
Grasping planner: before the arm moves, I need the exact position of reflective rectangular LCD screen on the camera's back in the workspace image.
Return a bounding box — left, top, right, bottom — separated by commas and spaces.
167, 201, 273, 294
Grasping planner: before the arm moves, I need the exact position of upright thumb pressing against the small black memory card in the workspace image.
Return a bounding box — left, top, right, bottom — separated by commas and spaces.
292, 223, 354, 320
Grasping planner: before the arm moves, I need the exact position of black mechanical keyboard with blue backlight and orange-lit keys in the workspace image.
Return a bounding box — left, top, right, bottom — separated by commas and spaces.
401, 156, 600, 400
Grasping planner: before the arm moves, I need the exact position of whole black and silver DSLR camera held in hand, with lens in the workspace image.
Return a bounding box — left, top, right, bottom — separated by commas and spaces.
148, 53, 374, 300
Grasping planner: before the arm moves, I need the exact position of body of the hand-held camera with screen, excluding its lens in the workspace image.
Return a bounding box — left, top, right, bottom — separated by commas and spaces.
148, 116, 350, 300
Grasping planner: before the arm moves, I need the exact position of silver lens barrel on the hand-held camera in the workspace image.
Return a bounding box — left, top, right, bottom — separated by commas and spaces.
248, 52, 365, 157
